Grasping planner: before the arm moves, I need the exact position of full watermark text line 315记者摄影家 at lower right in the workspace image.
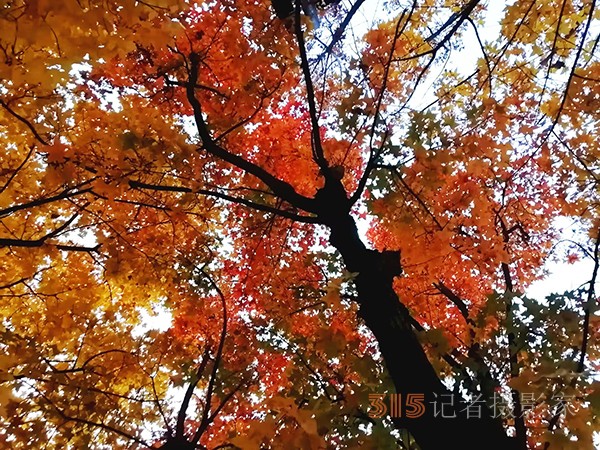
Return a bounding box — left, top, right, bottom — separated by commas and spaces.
368, 392, 574, 419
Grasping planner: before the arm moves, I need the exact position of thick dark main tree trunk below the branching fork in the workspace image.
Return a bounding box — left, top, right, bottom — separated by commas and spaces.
320, 179, 516, 450
